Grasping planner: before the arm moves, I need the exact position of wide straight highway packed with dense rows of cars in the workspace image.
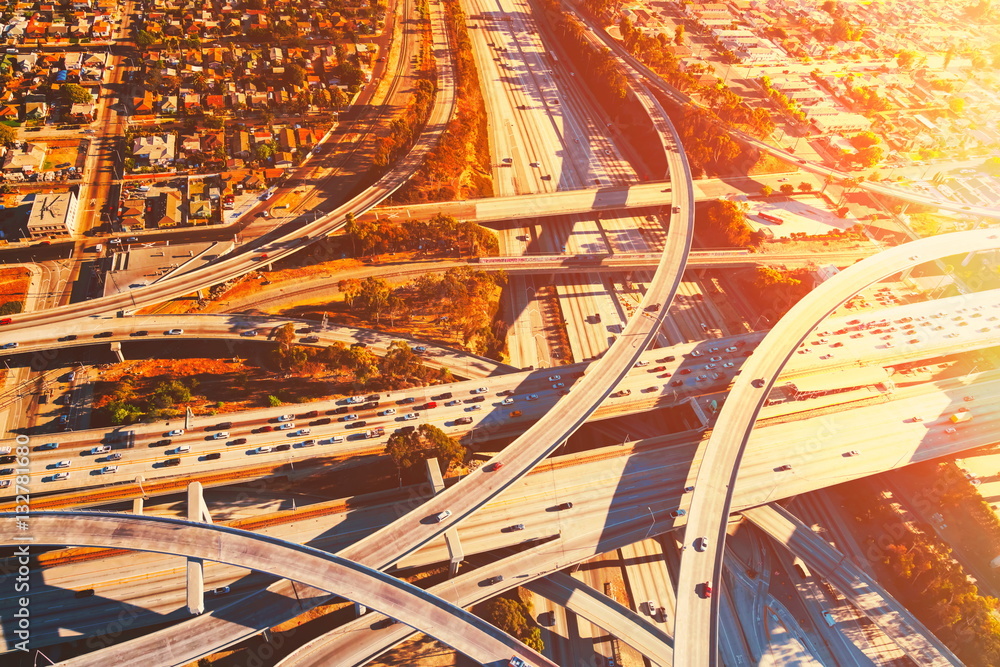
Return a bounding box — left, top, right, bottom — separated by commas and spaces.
0, 284, 1000, 508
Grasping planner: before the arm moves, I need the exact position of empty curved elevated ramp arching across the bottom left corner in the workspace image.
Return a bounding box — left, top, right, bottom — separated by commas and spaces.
0, 512, 557, 667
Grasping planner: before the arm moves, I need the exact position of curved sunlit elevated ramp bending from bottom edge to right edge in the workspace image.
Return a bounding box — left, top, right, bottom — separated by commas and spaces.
674, 229, 1000, 667
